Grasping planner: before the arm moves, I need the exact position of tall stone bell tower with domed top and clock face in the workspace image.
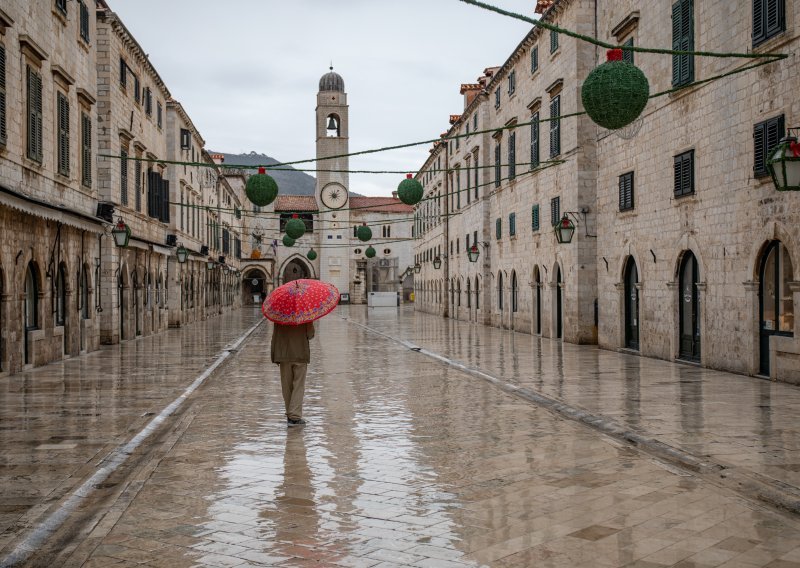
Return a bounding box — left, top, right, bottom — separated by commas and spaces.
315, 67, 351, 293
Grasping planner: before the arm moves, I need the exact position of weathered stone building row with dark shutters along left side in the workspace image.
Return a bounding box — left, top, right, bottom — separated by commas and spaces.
0, 0, 242, 374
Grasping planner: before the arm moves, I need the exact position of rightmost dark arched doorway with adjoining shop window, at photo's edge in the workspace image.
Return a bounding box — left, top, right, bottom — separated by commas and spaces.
758, 241, 794, 377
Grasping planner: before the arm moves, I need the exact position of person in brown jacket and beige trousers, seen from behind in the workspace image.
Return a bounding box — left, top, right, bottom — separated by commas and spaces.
272, 322, 314, 427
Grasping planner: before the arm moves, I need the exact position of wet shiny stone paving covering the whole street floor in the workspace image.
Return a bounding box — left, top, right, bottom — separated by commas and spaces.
0, 307, 800, 568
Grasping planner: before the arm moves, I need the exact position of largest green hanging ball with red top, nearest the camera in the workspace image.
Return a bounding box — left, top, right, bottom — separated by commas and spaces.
581, 61, 650, 130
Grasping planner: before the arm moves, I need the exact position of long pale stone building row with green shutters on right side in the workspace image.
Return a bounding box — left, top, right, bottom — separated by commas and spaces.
415, 0, 800, 382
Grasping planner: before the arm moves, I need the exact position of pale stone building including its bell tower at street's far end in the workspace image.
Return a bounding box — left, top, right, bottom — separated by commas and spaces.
236, 70, 414, 303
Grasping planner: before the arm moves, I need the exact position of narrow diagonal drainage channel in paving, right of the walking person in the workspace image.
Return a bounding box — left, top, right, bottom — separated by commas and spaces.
345, 318, 800, 515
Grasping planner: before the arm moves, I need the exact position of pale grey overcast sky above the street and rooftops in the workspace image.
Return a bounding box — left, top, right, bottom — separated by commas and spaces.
108, 0, 536, 195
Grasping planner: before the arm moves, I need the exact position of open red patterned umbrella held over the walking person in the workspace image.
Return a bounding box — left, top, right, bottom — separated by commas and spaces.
261, 279, 339, 325
